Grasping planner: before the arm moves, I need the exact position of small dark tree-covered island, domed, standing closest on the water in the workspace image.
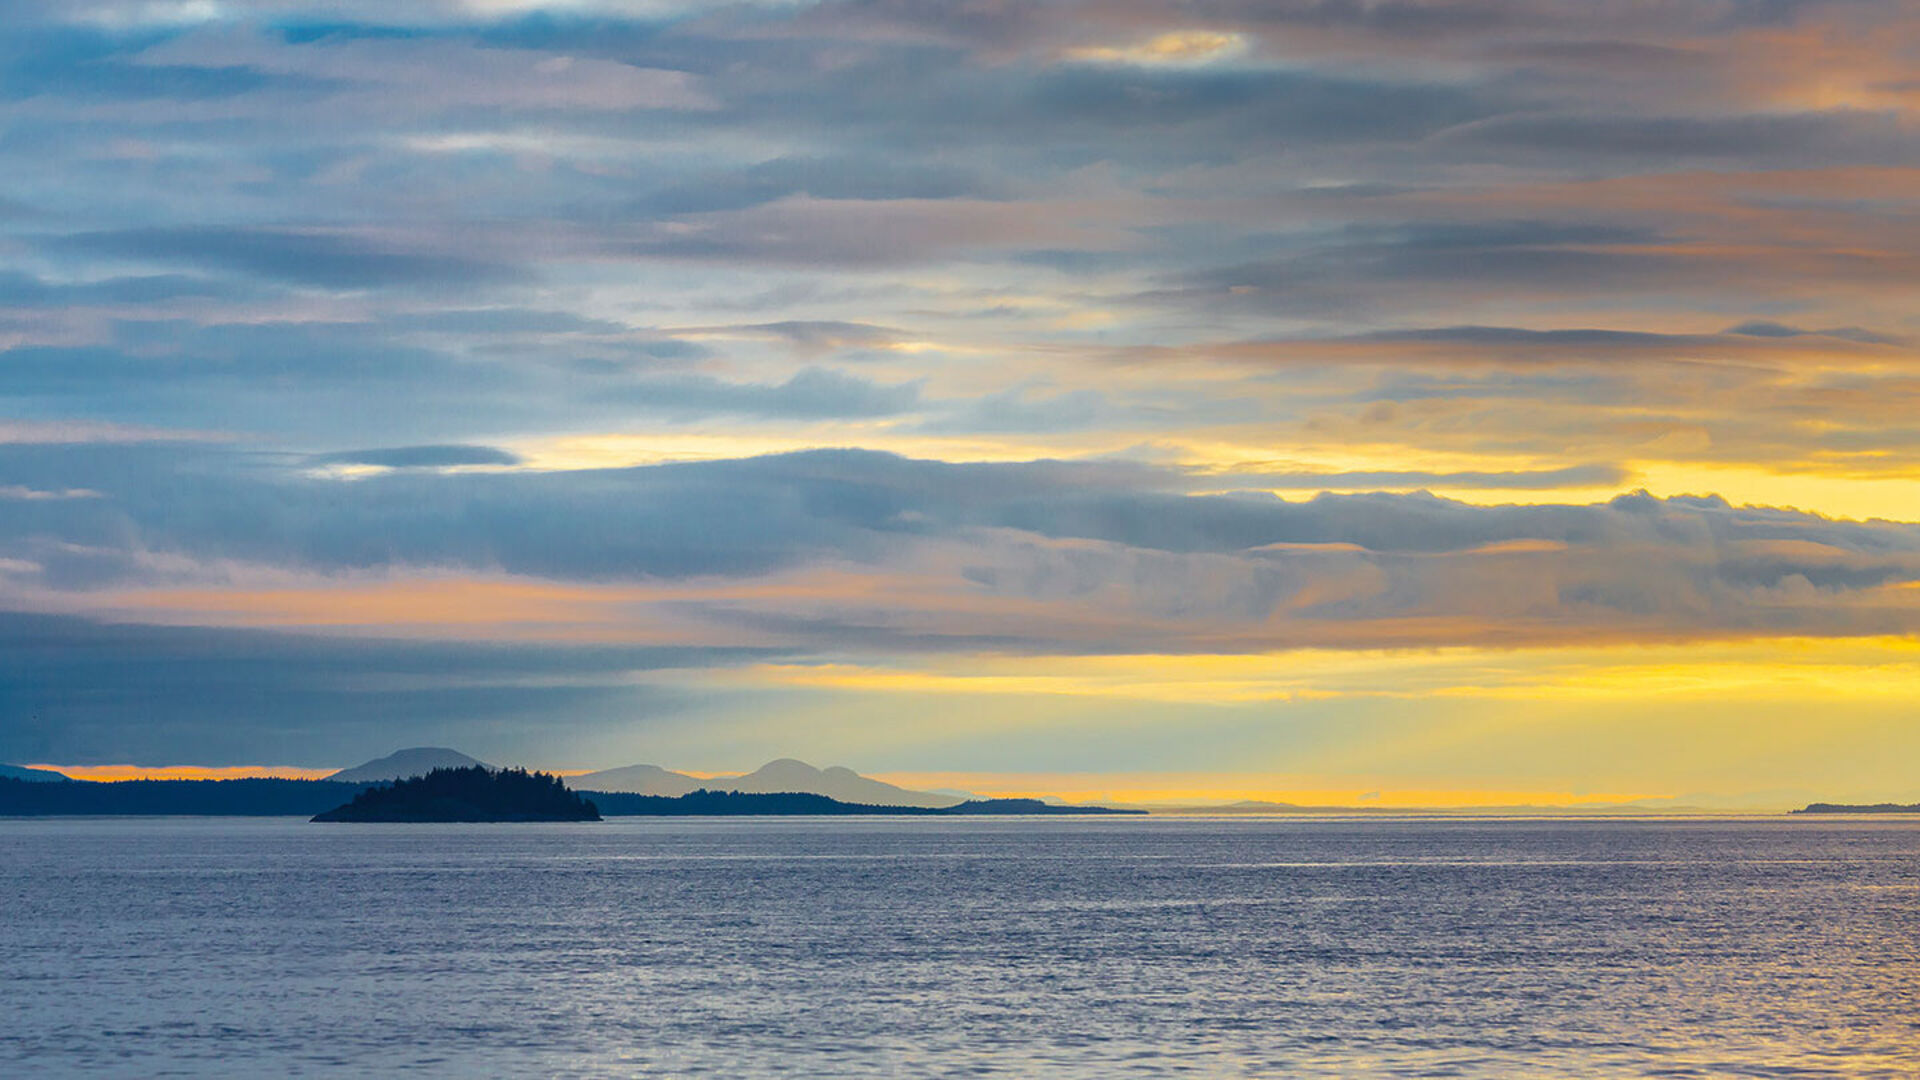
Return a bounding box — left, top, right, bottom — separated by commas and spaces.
313, 765, 599, 822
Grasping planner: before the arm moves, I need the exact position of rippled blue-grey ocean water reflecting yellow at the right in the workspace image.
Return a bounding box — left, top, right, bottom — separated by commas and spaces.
0, 819, 1920, 1078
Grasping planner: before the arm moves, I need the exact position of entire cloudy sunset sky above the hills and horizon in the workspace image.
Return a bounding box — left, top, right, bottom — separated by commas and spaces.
0, 0, 1920, 805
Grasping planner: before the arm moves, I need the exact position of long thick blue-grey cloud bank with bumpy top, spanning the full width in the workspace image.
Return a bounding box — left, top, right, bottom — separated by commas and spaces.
11, 448, 1920, 653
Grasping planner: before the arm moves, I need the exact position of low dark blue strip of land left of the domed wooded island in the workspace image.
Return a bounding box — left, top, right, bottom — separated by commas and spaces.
0, 776, 367, 817
